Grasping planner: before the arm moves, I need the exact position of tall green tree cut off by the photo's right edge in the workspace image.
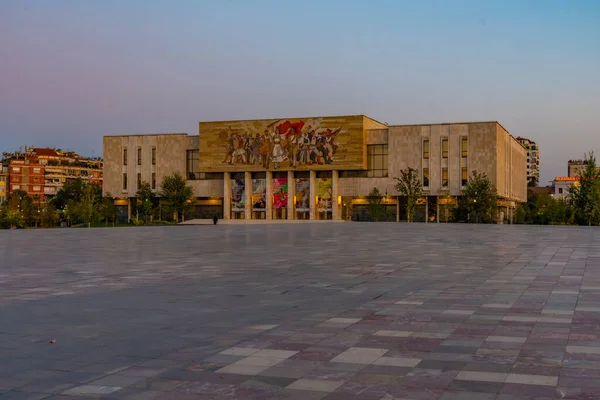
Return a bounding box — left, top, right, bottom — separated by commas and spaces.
569, 152, 600, 225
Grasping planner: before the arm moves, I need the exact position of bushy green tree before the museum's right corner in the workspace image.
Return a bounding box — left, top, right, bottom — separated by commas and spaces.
455, 171, 498, 224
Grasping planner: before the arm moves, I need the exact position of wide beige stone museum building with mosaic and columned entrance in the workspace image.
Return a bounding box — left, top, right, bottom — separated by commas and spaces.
103, 115, 527, 222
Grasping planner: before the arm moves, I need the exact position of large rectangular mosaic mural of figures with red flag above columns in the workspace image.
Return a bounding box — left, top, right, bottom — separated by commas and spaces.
199, 116, 365, 171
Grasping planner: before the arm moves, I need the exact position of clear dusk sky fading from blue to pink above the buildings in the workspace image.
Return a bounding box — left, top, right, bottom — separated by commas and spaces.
0, 0, 600, 185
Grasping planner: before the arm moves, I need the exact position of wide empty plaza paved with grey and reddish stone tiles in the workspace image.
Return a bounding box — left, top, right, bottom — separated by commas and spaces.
0, 223, 600, 400
